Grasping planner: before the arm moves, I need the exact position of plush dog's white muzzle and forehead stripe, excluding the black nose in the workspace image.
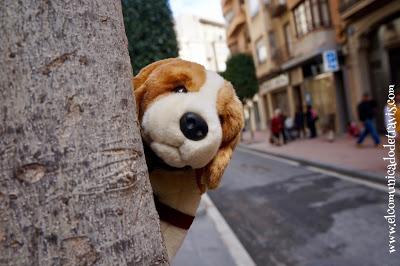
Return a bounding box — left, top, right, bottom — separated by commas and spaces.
142, 71, 224, 168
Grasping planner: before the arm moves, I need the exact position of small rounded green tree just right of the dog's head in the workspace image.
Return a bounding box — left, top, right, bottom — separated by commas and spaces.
222, 53, 258, 102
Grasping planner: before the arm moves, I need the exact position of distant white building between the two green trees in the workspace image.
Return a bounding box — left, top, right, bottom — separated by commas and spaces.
175, 15, 229, 72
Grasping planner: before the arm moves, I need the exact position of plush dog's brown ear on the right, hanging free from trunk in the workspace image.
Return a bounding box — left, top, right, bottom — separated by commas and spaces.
203, 82, 244, 189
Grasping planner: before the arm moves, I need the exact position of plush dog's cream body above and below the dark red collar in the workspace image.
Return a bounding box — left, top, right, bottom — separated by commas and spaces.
150, 169, 201, 260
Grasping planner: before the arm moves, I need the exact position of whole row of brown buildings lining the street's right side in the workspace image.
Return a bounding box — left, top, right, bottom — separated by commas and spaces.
222, 0, 400, 133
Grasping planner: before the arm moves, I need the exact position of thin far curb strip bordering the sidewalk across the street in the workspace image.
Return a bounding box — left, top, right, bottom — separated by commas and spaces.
238, 144, 388, 187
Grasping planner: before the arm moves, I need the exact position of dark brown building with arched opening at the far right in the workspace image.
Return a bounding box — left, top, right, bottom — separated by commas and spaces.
339, 0, 400, 130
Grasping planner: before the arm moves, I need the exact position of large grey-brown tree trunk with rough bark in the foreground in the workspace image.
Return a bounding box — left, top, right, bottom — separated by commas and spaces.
0, 0, 167, 265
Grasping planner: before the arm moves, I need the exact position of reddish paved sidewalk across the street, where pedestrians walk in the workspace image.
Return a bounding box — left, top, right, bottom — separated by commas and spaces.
241, 131, 388, 180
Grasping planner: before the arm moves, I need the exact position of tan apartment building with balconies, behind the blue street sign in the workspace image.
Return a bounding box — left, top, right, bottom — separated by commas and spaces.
241, 0, 348, 131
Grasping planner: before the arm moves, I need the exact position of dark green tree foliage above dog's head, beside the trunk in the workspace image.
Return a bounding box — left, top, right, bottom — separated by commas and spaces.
122, 0, 178, 74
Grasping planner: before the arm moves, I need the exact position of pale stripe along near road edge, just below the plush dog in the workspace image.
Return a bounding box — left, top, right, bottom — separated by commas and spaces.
201, 194, 256, 266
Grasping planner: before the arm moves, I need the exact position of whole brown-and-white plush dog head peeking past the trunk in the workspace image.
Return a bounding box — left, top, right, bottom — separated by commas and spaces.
133, 58, 243, 189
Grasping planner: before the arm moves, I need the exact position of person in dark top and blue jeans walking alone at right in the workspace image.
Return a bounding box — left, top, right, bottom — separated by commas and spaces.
357, 93, 381, 146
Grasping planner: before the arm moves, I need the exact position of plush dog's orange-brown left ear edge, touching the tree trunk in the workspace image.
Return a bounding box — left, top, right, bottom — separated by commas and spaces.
132, 58, 177, 119
